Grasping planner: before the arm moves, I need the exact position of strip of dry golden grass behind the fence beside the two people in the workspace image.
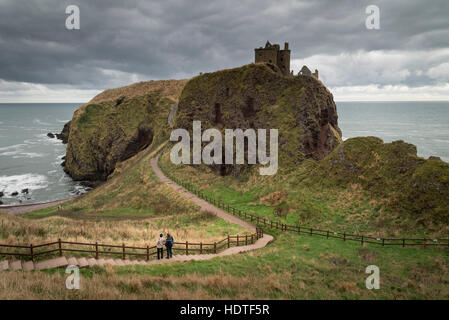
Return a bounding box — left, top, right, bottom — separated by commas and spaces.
0, 212, 250, 251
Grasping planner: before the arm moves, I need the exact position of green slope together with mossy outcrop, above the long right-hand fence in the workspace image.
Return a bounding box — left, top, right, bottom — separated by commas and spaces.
161, 137, 449, 237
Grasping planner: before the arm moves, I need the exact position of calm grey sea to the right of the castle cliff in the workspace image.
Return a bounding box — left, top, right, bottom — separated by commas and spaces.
336, 101, 449, 162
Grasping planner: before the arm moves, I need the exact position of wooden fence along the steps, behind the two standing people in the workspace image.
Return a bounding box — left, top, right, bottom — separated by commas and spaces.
0, 228, 263, 261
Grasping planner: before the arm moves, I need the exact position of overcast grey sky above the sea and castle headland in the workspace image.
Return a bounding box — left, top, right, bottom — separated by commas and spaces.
0, 0, 449, 102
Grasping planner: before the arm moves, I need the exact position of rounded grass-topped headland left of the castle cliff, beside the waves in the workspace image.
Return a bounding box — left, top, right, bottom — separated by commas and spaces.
61, 80, 186, 181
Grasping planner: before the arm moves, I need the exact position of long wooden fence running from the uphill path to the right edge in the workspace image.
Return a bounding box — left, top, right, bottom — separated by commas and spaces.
160, 165, 449, 248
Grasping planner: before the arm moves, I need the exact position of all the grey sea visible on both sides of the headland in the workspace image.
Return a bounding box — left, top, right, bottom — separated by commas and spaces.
0, 102, 449, 205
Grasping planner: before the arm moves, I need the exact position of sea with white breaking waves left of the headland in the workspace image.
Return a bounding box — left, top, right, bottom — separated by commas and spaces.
0, 103, 88, 205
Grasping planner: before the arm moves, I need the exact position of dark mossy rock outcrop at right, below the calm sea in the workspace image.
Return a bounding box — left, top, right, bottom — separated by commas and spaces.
316, 137, 449, 223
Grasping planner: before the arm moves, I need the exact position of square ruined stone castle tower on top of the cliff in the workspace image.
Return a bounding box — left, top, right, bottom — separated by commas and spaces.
254, 41, 291, 76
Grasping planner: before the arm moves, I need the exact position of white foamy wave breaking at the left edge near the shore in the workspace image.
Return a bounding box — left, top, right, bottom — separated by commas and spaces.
0, 173, 48, 198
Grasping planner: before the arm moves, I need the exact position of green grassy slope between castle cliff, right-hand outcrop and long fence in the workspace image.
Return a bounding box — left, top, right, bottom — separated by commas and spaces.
160, 147, 449, 238
